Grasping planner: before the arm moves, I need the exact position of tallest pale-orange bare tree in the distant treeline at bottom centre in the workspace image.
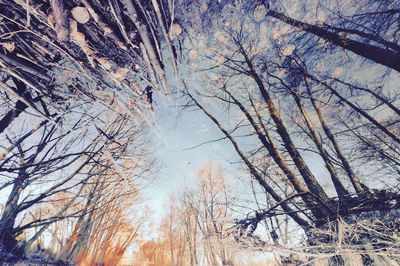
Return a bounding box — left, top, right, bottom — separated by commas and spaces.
187, 161, 233, 265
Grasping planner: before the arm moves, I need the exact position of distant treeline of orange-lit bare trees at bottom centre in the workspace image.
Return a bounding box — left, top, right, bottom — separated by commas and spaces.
132, 161, 276, 265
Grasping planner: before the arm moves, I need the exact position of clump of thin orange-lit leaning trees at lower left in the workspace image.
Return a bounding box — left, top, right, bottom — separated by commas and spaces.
60, 167, 147, 264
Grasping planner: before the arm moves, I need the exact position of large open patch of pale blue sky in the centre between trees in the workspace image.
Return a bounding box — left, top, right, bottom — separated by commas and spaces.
142, 92, 235, 222
